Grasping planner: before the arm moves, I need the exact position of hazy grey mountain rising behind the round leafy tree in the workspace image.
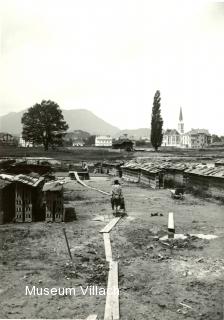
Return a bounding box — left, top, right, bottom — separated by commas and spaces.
0, 109, 119, 135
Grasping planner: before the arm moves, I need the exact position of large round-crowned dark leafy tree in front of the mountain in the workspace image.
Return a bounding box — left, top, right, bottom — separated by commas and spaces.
21, 100, 68, 150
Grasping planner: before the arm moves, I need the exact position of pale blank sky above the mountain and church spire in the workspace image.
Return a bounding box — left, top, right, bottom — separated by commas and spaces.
0, 0, 224, 135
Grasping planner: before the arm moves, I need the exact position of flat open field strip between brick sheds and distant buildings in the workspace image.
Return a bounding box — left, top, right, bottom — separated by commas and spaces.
0, 146, 224, 162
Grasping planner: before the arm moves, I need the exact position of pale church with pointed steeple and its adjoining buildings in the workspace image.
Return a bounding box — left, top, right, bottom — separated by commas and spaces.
162, 108, 211, 149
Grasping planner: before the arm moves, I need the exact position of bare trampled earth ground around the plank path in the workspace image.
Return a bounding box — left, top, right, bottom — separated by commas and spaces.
0, 178, 224, 320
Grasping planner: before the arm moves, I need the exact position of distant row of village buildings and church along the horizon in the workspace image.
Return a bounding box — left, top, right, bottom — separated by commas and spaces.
0, 108, 224, 151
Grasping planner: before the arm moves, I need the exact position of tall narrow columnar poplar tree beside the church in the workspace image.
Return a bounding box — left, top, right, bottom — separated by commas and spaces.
151, 90, 163, 151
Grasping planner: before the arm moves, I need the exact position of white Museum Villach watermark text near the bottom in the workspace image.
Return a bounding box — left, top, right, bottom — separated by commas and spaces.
25, 285, 119, 296
